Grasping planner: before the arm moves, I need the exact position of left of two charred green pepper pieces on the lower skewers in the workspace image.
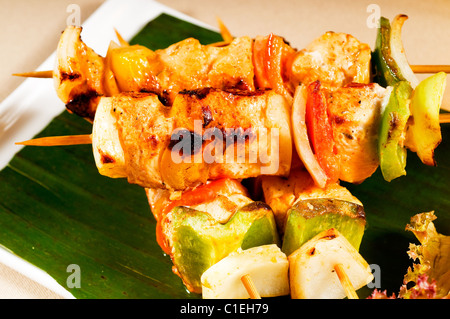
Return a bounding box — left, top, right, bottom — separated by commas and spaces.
162, 202, 280, 293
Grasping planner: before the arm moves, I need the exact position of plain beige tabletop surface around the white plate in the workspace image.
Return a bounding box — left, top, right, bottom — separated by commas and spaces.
0, 0, 450, 298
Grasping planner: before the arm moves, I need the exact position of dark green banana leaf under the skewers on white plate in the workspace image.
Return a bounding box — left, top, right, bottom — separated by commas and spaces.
0, 14, 450, 299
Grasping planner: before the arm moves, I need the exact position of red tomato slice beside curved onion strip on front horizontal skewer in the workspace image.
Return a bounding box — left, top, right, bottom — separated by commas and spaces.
306, 81, 339, 183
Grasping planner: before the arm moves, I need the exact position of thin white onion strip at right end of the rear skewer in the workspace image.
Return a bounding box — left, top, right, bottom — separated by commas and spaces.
390, 14, 419, 89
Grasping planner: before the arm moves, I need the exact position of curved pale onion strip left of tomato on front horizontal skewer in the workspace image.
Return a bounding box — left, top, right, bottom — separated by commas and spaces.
291, 85, 328, 188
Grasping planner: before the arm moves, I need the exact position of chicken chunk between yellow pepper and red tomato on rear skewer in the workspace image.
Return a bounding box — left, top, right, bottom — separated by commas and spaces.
155, 37, 255, 101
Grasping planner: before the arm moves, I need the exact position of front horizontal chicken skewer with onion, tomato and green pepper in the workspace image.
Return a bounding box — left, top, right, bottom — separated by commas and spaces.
16, 69, 440, 189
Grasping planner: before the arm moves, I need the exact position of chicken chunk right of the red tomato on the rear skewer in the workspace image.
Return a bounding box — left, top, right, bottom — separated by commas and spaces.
289, 31, 371, 88
